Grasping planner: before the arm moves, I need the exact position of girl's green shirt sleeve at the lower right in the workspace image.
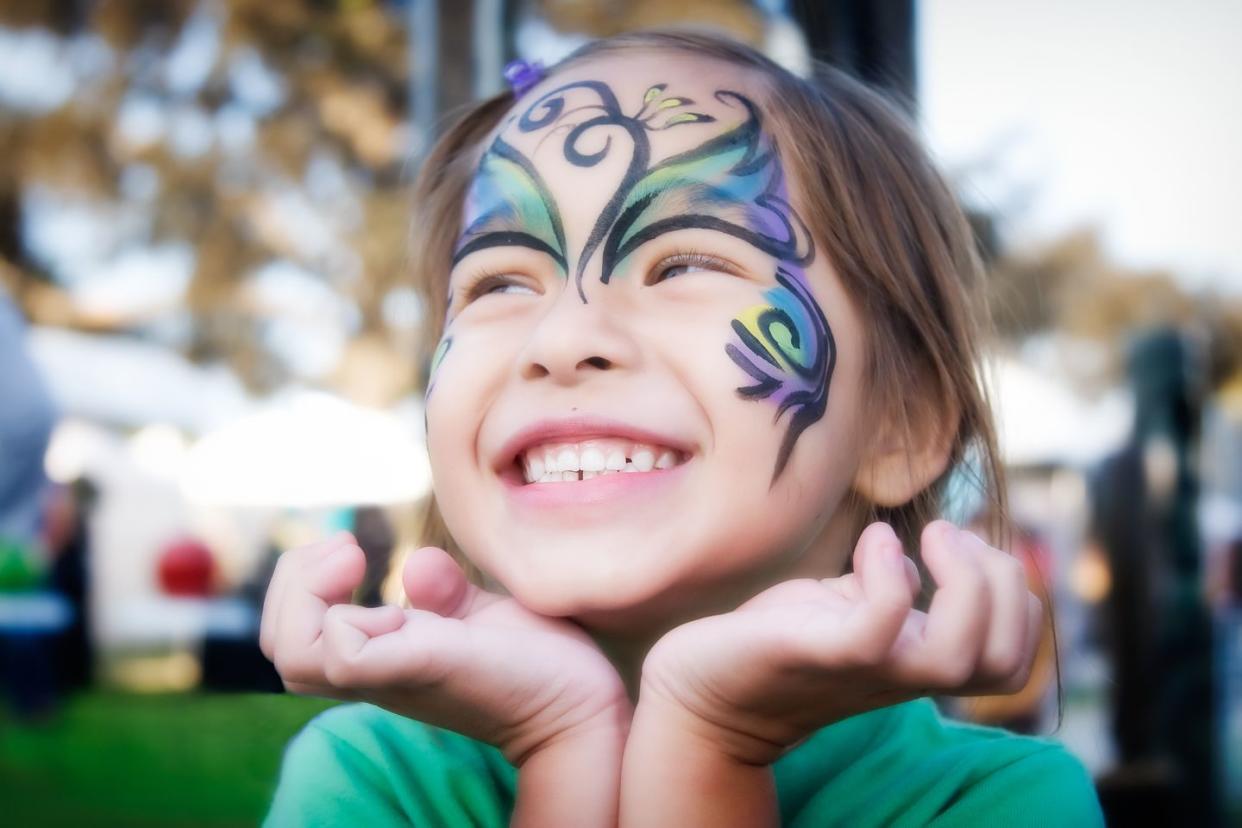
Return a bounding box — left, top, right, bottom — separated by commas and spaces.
930, 745, 1104, 828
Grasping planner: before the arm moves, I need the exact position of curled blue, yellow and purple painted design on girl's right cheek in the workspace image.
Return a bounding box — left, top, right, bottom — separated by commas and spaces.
724, 268, 837, 483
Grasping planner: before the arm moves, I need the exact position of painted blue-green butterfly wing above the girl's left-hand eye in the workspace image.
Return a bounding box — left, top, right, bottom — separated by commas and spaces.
453, 138, 568, 274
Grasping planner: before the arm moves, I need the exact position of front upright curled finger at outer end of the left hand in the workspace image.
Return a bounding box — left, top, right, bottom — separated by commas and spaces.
276, 545, 366, 684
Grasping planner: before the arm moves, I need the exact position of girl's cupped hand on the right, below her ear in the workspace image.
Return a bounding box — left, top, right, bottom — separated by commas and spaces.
638, 520, 1042, 765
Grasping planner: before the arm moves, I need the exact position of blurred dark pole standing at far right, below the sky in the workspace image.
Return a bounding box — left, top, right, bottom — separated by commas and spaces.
1095, 329, 1220, 827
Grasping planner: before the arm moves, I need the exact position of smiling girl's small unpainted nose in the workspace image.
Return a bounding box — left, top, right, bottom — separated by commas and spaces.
520, 286, 638, 385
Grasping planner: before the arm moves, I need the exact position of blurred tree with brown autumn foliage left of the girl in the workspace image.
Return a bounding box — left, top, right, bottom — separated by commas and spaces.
0, 0, 414, 394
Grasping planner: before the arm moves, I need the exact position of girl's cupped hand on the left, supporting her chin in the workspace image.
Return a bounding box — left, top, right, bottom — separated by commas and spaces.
260, 533, 632, 767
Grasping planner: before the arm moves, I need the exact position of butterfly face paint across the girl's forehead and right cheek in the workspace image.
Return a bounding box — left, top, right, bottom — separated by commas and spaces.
448, 81, 836, 483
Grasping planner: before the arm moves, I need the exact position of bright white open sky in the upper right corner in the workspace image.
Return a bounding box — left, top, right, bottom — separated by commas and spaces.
917, 0, 1242, 295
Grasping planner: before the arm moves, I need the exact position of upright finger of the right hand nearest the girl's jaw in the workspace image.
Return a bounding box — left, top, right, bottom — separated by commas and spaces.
842, 523, 914, 664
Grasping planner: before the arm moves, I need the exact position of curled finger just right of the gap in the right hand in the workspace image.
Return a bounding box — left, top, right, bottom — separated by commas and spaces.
909, 520, 991, 690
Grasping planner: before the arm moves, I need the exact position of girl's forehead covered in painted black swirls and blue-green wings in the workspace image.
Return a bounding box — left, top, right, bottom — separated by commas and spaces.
458, 52, 787, 258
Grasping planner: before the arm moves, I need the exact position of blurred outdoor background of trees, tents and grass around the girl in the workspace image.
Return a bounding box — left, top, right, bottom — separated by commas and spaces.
0, 0, 1242, 826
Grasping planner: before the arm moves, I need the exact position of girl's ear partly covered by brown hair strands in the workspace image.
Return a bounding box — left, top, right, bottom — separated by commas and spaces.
853, 401, 961, 508
